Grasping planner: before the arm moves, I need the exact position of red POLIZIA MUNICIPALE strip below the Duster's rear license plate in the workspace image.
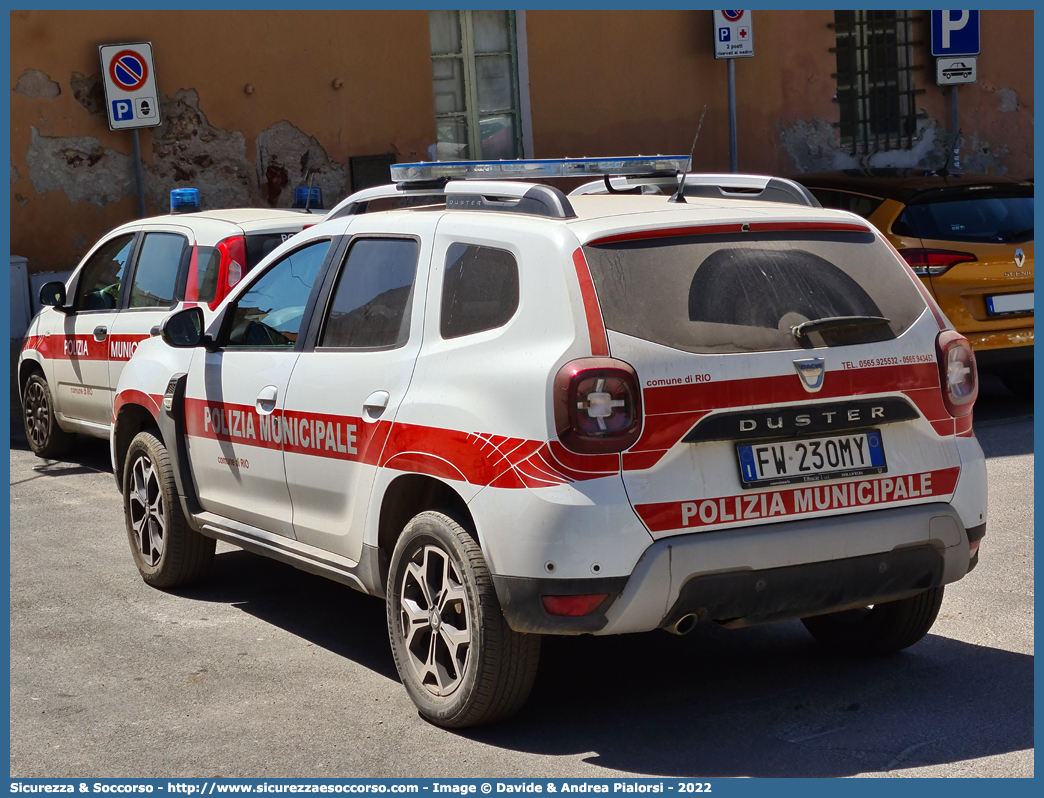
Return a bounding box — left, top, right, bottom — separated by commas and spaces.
635, 466, 960, 532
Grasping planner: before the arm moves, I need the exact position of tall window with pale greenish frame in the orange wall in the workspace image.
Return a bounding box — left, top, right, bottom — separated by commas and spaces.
428, 10, 522, 161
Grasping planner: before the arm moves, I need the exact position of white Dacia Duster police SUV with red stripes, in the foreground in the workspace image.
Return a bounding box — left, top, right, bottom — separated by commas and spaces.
112, 158, 987, 726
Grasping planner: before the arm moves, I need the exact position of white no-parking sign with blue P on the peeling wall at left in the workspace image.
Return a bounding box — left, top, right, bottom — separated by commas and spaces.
98, 42, 160, 131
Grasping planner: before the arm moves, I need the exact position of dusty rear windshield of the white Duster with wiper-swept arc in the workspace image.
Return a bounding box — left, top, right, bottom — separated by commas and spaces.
584, 232, 925, 353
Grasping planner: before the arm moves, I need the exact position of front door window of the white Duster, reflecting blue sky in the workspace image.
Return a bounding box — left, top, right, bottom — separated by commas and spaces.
229, 240, 330, 349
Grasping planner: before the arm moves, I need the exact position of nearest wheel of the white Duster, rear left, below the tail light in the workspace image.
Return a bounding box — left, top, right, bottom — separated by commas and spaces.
387, 511, 540, 728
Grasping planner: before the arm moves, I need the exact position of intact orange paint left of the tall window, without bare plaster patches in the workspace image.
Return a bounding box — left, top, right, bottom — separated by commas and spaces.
9, 10, 435, 271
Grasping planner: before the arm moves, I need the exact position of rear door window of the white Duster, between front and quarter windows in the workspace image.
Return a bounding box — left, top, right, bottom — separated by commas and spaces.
319, 238, 421, 349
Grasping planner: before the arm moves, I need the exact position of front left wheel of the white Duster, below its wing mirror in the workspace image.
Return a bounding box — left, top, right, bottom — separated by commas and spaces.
123, 432, 216, 588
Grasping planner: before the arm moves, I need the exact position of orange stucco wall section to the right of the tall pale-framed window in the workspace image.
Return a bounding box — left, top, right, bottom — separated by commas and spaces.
526, 10, 1034, 177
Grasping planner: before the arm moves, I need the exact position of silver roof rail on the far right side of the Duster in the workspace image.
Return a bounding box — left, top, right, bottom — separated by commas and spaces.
569, 172, 823, 208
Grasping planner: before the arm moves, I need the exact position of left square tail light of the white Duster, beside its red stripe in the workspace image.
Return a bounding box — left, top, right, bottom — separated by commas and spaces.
554, 357, 642, 454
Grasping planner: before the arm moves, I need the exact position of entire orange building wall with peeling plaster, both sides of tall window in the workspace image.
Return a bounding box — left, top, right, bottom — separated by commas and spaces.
9, 10, 1034, 271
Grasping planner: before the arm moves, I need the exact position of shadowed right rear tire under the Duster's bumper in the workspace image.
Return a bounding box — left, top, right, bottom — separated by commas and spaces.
801, 587, 943, 656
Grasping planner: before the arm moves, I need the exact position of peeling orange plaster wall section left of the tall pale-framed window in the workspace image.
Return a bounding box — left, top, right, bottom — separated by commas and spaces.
9, 9, 435, 272
